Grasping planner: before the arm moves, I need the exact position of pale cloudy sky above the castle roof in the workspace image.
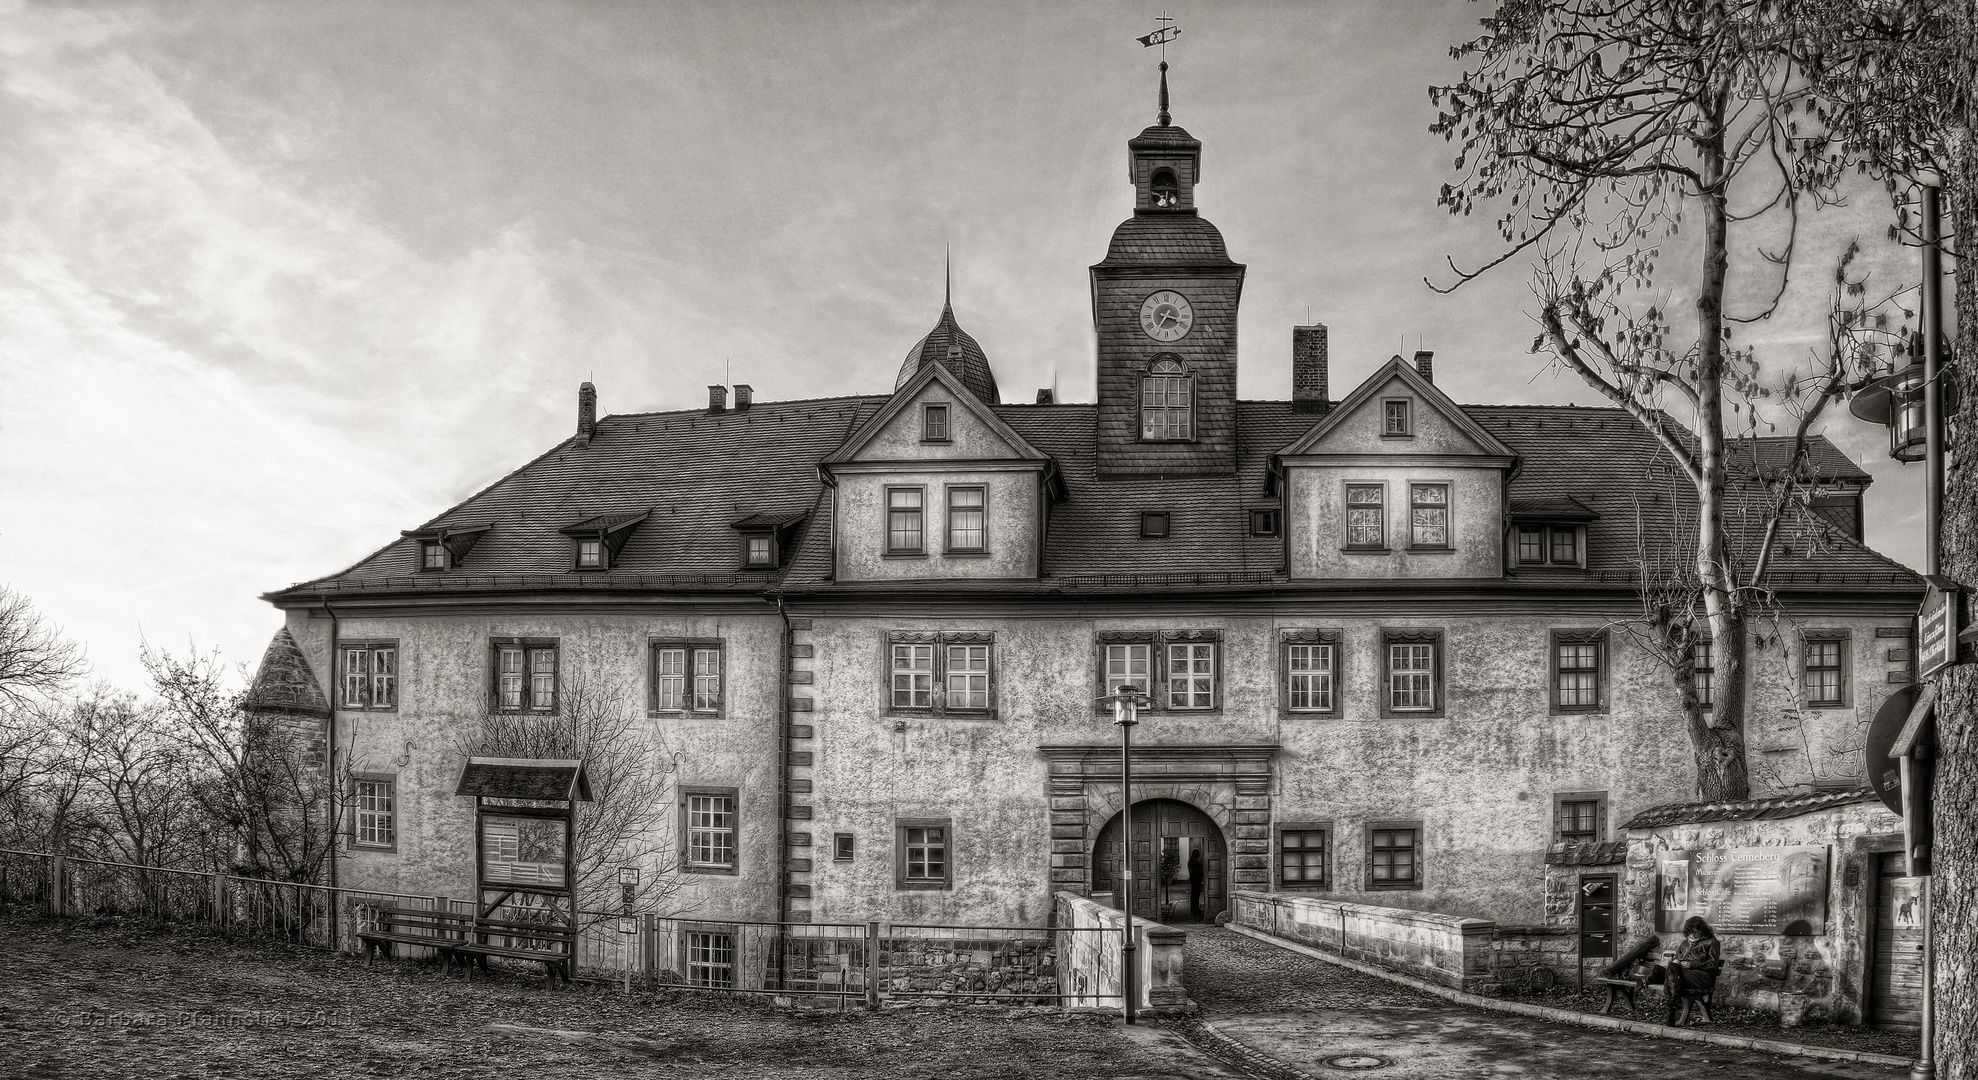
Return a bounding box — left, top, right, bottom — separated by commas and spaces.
0, 0, 1919, 682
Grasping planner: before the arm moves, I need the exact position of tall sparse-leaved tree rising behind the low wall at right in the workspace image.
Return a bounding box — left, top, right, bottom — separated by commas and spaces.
1430, 0, 1847, 801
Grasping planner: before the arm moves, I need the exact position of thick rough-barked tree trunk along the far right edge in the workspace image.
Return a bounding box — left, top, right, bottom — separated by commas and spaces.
1931, 52, 1978, 1080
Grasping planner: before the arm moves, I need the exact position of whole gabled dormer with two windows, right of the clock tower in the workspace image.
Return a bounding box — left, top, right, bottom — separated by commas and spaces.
1278, 356, 1517, 580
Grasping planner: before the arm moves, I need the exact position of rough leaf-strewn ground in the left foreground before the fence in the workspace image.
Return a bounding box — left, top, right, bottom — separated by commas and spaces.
0, 912, 1224, 1080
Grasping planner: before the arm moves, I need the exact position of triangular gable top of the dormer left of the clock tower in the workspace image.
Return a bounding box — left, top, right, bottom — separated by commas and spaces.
823, 360, 1048, 467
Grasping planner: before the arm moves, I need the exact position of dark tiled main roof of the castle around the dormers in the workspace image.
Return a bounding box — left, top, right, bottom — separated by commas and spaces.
269, 396, 1919, 599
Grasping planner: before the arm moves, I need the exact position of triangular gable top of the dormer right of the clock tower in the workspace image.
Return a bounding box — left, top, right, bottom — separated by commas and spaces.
1278, 356, 1517, 457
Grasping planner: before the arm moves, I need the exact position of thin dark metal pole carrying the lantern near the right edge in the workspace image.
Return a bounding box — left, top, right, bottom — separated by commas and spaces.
1909, 178, 1954, 1080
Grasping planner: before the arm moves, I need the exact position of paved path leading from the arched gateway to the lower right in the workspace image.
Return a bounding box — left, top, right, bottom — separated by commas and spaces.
1183, 928, 1907, 1080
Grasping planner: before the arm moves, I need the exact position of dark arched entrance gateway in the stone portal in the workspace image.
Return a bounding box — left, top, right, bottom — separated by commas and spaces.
1092, 799, 1228, 922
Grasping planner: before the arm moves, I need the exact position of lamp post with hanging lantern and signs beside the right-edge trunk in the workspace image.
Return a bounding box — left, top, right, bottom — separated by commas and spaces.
1847, 176, 1956, 1080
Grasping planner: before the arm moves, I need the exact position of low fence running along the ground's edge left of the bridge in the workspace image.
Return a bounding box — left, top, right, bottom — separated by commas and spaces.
0, 849, 1120, 1009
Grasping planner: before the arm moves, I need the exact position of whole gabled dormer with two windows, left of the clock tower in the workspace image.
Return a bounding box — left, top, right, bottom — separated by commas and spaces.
819, 360, 1064, 582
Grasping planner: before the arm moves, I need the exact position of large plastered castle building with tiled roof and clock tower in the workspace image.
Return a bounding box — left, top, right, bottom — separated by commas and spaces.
247, 75, 1919, 937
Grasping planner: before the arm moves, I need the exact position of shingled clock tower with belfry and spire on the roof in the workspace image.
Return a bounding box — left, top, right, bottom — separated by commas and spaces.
1092, 63, 1244, 477
